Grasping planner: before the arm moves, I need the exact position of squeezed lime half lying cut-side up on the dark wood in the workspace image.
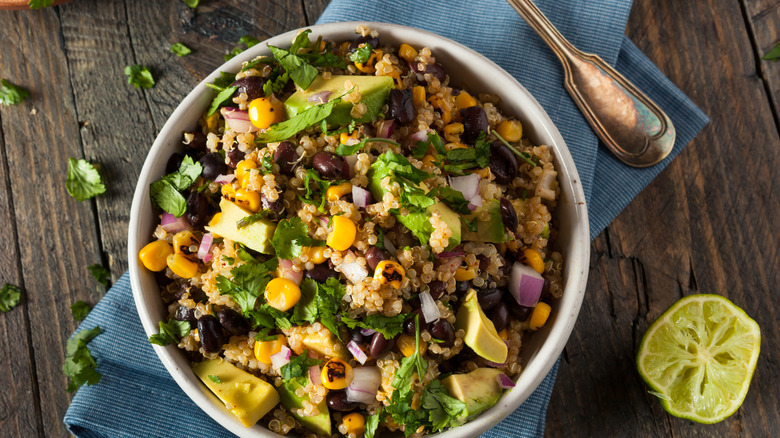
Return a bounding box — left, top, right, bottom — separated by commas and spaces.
636, 294, 761, 423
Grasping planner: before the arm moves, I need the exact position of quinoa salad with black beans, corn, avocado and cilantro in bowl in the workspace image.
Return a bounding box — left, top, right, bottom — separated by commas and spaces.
138, 26, 563, 438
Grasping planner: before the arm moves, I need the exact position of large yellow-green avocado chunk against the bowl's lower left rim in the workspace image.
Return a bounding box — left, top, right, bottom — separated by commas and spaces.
192, 359, 279, 427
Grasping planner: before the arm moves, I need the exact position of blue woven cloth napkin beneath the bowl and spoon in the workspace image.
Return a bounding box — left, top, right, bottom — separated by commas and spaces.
64, 0, 708, 438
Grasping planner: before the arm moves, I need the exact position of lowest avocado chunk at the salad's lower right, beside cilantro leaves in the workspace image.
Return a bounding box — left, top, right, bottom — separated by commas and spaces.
442, 368, 504, 422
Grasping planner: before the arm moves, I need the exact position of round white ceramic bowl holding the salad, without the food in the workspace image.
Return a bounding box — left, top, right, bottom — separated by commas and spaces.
128, 22, 590, 437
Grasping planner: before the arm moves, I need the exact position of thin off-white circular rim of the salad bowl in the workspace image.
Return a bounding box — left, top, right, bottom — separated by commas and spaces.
128, 21, 590, 437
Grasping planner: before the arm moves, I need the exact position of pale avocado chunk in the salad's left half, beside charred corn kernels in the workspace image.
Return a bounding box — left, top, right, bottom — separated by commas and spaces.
206, 198, 276, 254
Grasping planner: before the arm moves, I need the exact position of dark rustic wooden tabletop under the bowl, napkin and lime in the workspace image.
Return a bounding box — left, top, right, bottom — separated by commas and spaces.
0, 0, 780, 437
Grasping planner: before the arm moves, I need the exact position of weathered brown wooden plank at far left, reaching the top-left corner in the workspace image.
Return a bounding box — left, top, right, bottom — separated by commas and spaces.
0, 8, 101, 436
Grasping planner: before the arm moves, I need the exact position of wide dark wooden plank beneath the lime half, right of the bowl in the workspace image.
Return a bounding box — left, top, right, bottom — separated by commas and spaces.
547, 0, 780, 436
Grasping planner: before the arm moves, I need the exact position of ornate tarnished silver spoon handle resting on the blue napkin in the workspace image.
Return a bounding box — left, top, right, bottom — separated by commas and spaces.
507, 0, 675, 167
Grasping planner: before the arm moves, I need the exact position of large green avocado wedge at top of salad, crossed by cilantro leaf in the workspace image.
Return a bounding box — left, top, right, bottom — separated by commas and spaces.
284, 75, 393, 126
